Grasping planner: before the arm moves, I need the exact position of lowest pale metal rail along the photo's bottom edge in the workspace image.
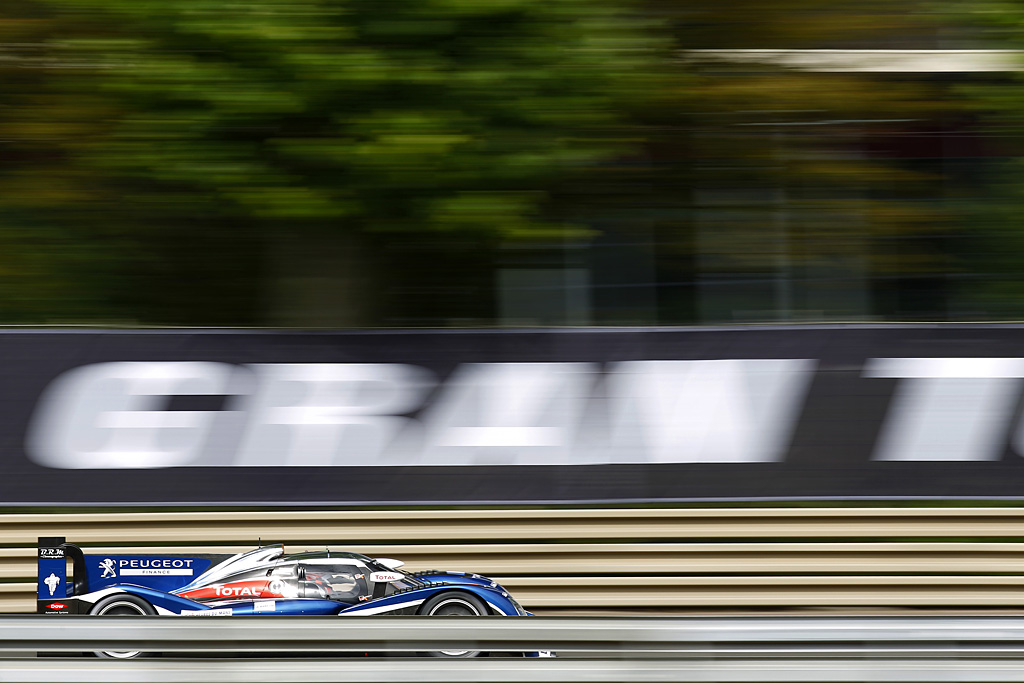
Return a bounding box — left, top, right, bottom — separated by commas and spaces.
16, 657, 1024, 683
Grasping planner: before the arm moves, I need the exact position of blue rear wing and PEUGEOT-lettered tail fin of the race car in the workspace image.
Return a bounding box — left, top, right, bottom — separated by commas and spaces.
36, 537, 231, 614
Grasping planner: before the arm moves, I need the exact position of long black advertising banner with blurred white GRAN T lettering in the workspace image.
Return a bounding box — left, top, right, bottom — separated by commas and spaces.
9, 325, 1024, 505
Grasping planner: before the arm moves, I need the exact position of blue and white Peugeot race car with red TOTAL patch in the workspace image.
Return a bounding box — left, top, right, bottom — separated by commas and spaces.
36, 538, 549, 658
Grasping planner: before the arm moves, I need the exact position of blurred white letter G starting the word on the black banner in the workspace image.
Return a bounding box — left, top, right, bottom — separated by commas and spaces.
26, 362, 234, 469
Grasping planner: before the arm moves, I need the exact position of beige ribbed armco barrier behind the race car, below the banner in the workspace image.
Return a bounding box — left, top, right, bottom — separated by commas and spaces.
6, 507, 1024, 615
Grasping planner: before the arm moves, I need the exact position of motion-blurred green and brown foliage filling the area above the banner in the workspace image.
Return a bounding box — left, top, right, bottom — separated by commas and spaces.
0, 0, 1016, 327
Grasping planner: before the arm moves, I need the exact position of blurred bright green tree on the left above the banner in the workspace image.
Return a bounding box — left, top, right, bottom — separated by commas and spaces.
0, 0, 668, 327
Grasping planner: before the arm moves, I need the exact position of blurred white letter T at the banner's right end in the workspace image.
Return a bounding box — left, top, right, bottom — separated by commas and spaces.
864, 358, 1024, 462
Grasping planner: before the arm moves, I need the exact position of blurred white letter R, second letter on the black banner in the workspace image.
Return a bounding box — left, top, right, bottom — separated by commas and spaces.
233, 364, 436, 467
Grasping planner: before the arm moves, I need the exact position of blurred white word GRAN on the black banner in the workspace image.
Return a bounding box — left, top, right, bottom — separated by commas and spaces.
27, 359, 815, 466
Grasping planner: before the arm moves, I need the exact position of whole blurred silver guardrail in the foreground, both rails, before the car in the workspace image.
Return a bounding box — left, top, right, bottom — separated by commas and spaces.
8, 616, 1024, 683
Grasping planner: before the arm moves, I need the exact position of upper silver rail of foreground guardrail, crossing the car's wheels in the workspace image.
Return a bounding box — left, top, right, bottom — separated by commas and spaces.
6, 615, 1024, 655
